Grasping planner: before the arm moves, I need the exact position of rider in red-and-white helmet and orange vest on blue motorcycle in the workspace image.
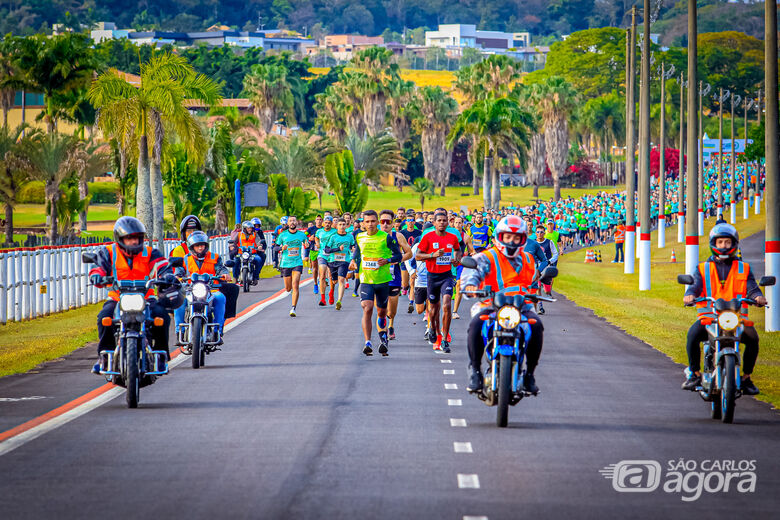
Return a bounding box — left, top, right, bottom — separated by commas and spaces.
460, 215, 544, 394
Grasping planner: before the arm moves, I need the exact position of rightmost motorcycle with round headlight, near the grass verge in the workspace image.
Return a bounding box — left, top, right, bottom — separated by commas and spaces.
677, 274, 775, 423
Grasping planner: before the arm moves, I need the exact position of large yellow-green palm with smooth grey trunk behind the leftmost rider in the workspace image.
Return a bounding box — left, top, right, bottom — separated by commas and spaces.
93, 53, 220, 240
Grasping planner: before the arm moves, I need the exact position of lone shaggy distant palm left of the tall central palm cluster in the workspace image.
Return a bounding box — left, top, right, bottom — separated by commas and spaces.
244, 64, 295, 134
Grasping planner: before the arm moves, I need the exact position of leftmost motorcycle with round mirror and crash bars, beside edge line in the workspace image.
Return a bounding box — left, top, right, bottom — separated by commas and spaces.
81, 253, 168, 408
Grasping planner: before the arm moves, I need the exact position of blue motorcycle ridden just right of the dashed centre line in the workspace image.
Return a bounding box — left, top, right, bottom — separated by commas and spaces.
460, 257, 558, 428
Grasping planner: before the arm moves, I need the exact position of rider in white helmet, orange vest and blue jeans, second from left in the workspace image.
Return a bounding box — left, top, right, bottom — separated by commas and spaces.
173, 231, 230, 345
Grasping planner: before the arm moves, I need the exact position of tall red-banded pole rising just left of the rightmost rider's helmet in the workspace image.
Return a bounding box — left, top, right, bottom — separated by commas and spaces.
685, 0, 699, 275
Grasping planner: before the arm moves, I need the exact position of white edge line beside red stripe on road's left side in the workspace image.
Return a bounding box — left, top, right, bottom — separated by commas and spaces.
0, 280, 311, 457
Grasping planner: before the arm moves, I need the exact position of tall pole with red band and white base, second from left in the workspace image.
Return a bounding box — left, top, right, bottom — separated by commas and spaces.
639, 0, 650, 291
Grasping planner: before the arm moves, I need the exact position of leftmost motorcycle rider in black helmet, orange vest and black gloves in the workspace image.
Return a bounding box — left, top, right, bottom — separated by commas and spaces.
89, 217, 183, 374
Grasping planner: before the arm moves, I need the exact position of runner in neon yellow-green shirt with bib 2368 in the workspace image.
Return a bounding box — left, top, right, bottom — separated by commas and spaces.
350, 210, 402, 356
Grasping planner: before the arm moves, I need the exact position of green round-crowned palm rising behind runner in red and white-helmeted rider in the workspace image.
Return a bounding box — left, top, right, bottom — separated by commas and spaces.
447, 96, 536, 208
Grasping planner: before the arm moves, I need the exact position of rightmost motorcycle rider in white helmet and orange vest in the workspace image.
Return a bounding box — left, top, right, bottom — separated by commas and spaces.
682, 223, 766, 395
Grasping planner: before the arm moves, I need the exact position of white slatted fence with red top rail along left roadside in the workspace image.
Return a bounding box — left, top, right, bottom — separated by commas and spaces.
0, 233, 272, 325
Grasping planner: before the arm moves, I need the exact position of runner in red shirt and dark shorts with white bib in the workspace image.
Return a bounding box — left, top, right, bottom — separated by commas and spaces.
415, 211, 461, 353
